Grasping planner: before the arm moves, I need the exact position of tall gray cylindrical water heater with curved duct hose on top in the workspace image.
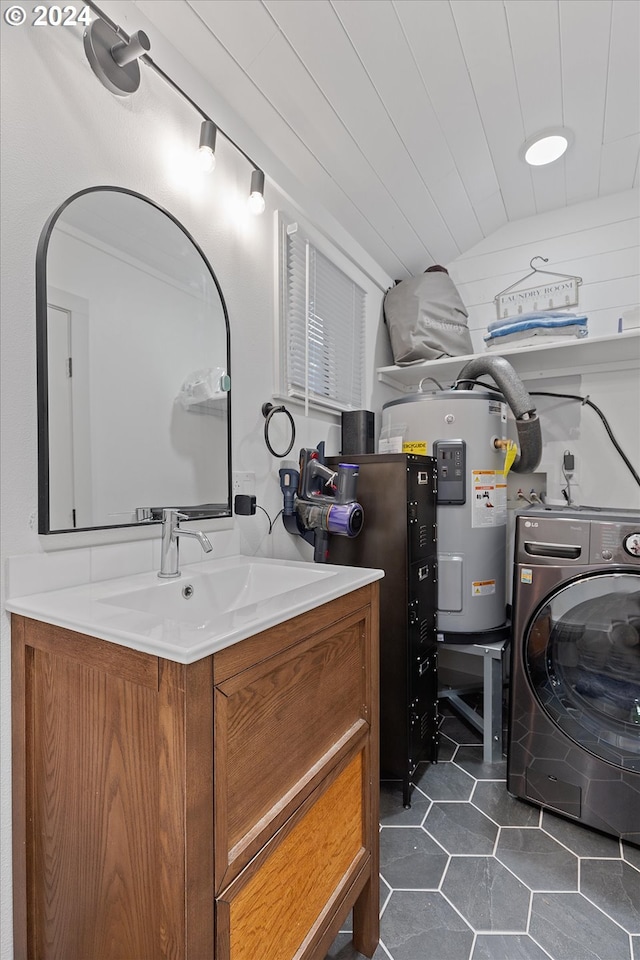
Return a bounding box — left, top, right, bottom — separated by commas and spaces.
382, 357, 542, 644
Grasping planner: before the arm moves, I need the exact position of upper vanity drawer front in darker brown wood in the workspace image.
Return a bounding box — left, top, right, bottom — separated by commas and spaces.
214, 608, 371, 890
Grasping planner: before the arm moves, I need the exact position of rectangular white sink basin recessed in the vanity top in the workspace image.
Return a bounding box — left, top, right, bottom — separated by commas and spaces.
101, 558, 337, 625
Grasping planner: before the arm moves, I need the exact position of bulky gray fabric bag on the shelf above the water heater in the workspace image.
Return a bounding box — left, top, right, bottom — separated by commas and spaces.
384, 267, 473, 366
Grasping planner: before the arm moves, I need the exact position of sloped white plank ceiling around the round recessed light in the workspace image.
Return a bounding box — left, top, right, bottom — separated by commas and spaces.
136, 0, 640, 279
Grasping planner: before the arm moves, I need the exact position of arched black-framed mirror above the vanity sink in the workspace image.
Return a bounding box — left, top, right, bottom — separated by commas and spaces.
36, 187, 231, 533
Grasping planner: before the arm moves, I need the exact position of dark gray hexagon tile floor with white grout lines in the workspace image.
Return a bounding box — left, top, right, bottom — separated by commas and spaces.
327, 703, 640, 960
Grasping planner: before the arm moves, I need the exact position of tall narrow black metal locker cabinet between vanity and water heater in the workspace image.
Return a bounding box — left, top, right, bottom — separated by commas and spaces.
327, 453, 438, 806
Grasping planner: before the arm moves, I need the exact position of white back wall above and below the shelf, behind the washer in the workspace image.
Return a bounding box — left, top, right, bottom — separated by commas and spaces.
449, 190, 640, 509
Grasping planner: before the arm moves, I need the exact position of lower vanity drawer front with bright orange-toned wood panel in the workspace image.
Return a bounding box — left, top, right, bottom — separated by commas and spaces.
216, 751, 368, 960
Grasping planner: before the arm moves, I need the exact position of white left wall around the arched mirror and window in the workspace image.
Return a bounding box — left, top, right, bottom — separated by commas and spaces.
0, 11, 391, 960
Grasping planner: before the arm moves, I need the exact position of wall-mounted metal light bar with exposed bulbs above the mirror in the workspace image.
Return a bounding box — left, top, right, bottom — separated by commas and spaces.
84, 0, 265, 214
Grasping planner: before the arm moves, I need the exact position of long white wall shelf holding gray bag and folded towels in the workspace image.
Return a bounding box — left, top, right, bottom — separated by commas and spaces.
377, 329, 640, 393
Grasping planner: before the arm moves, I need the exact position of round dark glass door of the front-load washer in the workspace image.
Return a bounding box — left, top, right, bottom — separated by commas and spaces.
524, 572, 640, 770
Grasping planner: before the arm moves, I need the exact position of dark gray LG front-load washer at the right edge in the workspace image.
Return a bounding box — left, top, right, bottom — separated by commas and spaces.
507, 507, 640, 845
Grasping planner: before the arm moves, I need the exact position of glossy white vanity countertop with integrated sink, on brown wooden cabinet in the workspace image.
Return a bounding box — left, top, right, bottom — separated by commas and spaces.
6, 556, 384, 663
